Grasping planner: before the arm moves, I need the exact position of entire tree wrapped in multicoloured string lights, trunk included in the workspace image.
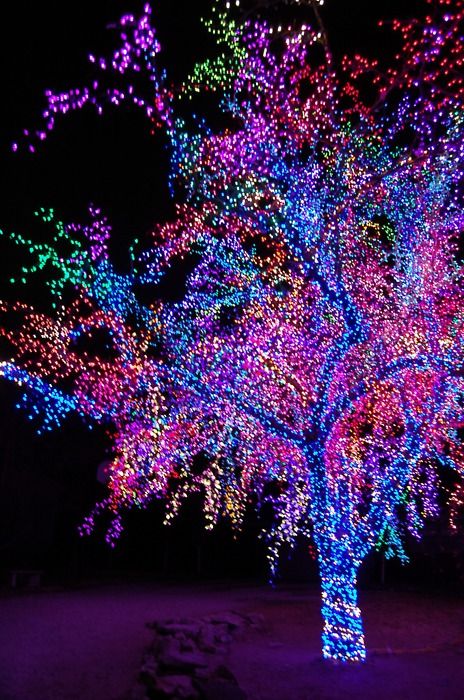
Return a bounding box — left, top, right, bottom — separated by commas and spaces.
0, 0, 464, 660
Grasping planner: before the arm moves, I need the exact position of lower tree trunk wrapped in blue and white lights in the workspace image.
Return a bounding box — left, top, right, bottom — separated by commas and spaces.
319, 540, 366, 661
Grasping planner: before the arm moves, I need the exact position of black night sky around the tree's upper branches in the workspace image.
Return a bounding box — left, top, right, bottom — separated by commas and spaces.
0, 0, 423, 246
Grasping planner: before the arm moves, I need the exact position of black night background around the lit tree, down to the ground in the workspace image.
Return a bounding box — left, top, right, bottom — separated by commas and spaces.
0, 0, 463, 586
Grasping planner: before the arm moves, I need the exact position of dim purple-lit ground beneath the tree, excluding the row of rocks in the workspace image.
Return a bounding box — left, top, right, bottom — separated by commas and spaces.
0, 583, 464, 700
